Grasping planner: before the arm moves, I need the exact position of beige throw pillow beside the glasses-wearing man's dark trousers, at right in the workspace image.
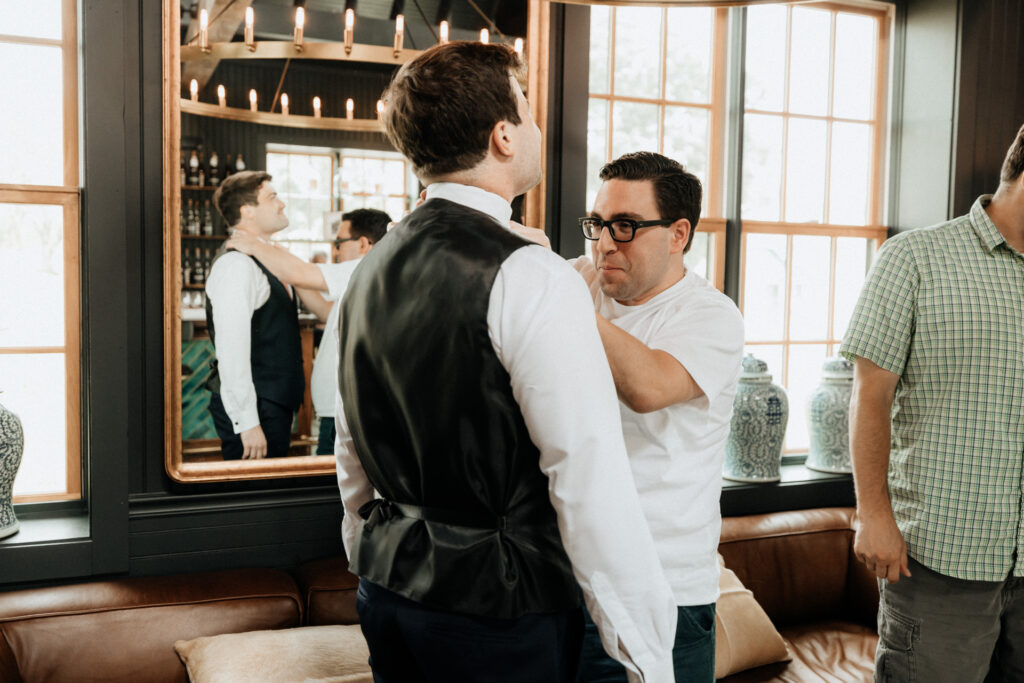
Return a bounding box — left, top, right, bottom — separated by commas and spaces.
715, 555, 793, 678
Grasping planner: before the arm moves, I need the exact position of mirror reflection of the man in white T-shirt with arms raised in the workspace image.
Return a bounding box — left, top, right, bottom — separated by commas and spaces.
226, 209, 391, 456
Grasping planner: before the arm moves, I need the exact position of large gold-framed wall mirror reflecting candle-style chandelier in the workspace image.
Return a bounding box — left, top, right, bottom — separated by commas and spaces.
163, 0, 546, 483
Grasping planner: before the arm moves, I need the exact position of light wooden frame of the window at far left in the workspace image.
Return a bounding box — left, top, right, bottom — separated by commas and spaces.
0, 0, 83, 504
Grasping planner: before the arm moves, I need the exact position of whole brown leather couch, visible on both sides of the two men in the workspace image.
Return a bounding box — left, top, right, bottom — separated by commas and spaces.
0, 509, 878, 683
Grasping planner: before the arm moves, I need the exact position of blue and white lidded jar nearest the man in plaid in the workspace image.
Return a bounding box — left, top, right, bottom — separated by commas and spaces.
807, 356, 853, 473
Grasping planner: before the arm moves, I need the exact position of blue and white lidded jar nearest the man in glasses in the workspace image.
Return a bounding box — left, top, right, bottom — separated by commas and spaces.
722, 354, 790, 481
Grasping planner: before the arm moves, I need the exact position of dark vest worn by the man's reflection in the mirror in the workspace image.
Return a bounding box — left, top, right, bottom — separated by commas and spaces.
206, 252, 306, 411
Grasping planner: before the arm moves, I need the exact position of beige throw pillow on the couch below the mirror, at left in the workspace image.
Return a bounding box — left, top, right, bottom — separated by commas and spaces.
174, 625, 374, 683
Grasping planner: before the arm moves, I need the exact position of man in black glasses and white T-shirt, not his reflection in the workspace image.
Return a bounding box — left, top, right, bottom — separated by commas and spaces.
572, 152, 743, 683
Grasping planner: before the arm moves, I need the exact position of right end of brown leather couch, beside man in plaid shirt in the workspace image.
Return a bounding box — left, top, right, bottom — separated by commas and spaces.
719, 508, 879, 683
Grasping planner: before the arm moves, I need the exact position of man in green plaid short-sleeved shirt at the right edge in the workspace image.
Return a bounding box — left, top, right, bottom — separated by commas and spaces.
840, 127, 1024, 683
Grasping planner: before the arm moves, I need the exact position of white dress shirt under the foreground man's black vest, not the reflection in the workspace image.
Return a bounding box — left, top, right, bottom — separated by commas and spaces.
335, 183, 676, 683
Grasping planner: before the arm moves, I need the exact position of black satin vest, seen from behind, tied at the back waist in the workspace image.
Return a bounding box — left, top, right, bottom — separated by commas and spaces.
339, 199, 580, 618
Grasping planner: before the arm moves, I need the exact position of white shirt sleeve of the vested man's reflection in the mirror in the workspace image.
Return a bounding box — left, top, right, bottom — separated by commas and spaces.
206, 251, 270, 434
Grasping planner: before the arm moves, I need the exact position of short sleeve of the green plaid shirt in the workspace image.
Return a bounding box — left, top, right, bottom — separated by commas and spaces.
840, 237, 921, 375
